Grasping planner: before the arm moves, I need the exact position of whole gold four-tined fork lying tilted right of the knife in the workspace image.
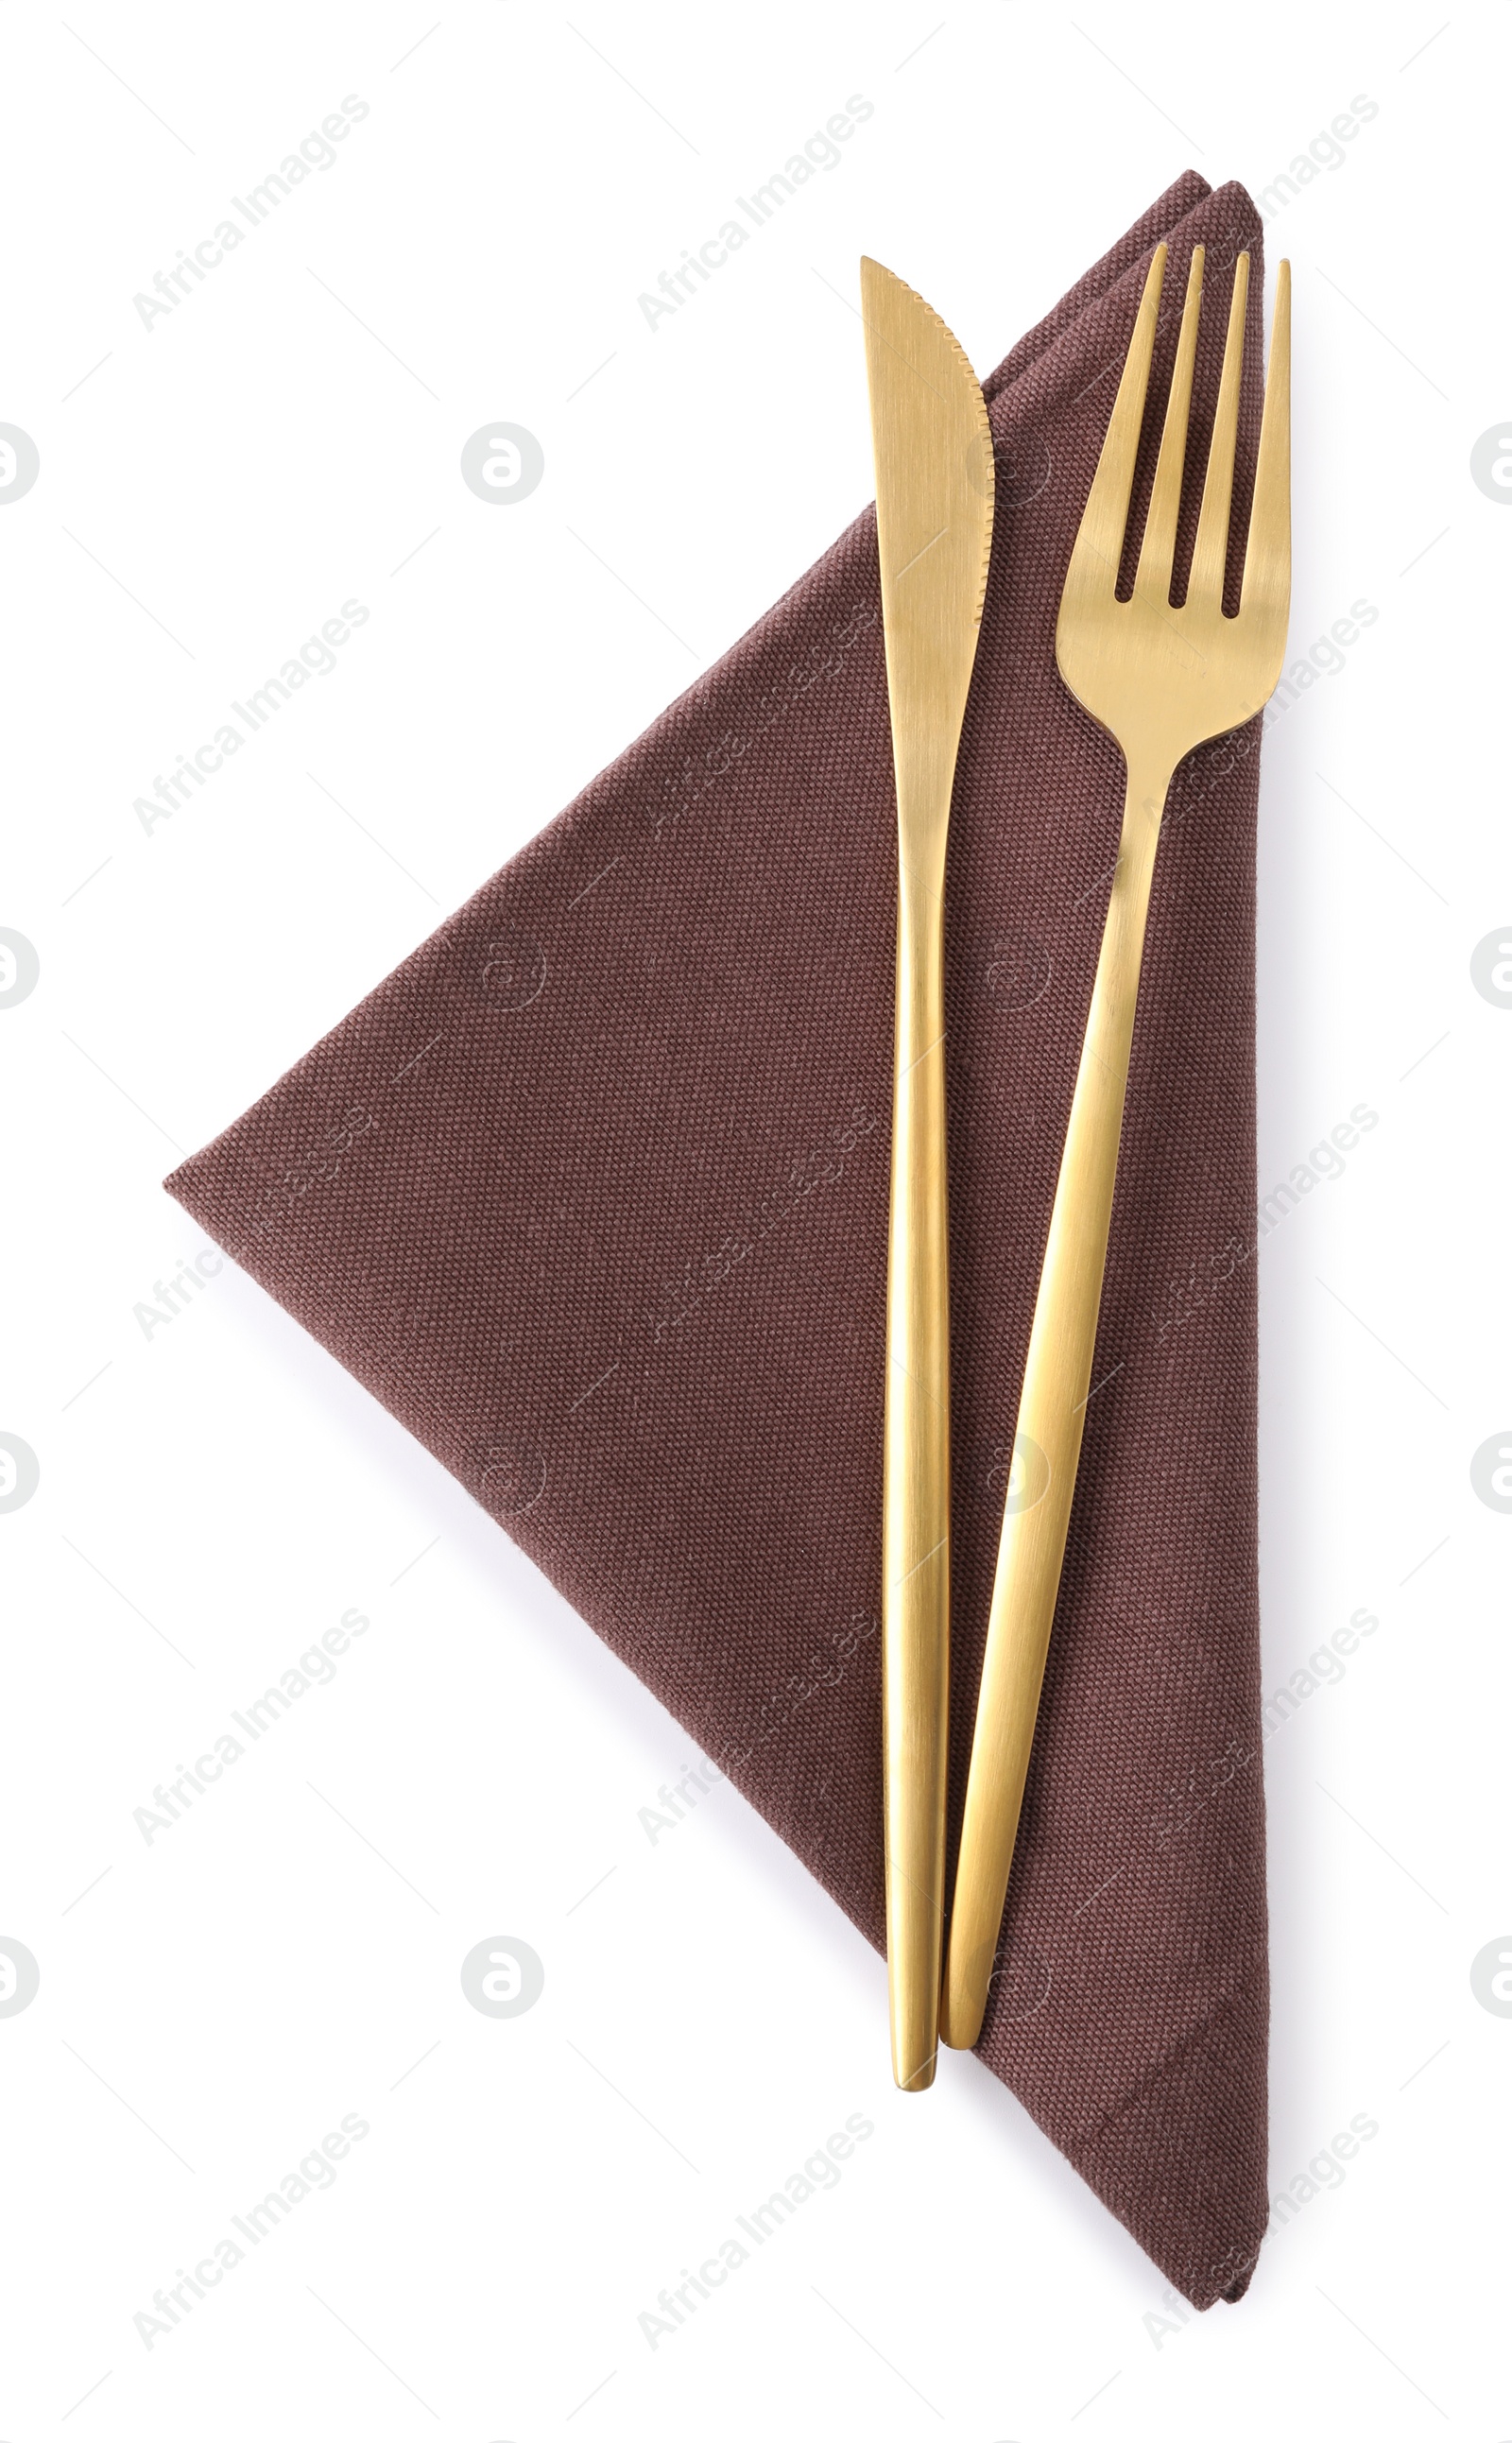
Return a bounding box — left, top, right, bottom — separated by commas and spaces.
940, 247, 1292, 2045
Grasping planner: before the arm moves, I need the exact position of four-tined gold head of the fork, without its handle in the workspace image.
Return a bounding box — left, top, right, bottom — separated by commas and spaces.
1056, 247, 1292, 801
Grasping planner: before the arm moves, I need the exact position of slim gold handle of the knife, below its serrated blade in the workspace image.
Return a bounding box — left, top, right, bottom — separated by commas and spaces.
882, 840, 950, 2091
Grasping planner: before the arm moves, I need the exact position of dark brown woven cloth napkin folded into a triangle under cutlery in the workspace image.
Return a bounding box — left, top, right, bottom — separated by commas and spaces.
168, 176, 1268, 2306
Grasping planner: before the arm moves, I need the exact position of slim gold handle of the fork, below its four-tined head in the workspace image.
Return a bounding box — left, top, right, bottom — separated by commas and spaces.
940, 772, 1168, 2045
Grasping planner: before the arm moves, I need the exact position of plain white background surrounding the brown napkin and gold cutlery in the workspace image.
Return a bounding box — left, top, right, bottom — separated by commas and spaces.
0, 0, 1512, 2443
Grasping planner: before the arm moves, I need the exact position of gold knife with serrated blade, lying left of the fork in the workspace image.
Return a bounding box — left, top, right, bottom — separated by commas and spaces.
860, 256, 991, 2091
